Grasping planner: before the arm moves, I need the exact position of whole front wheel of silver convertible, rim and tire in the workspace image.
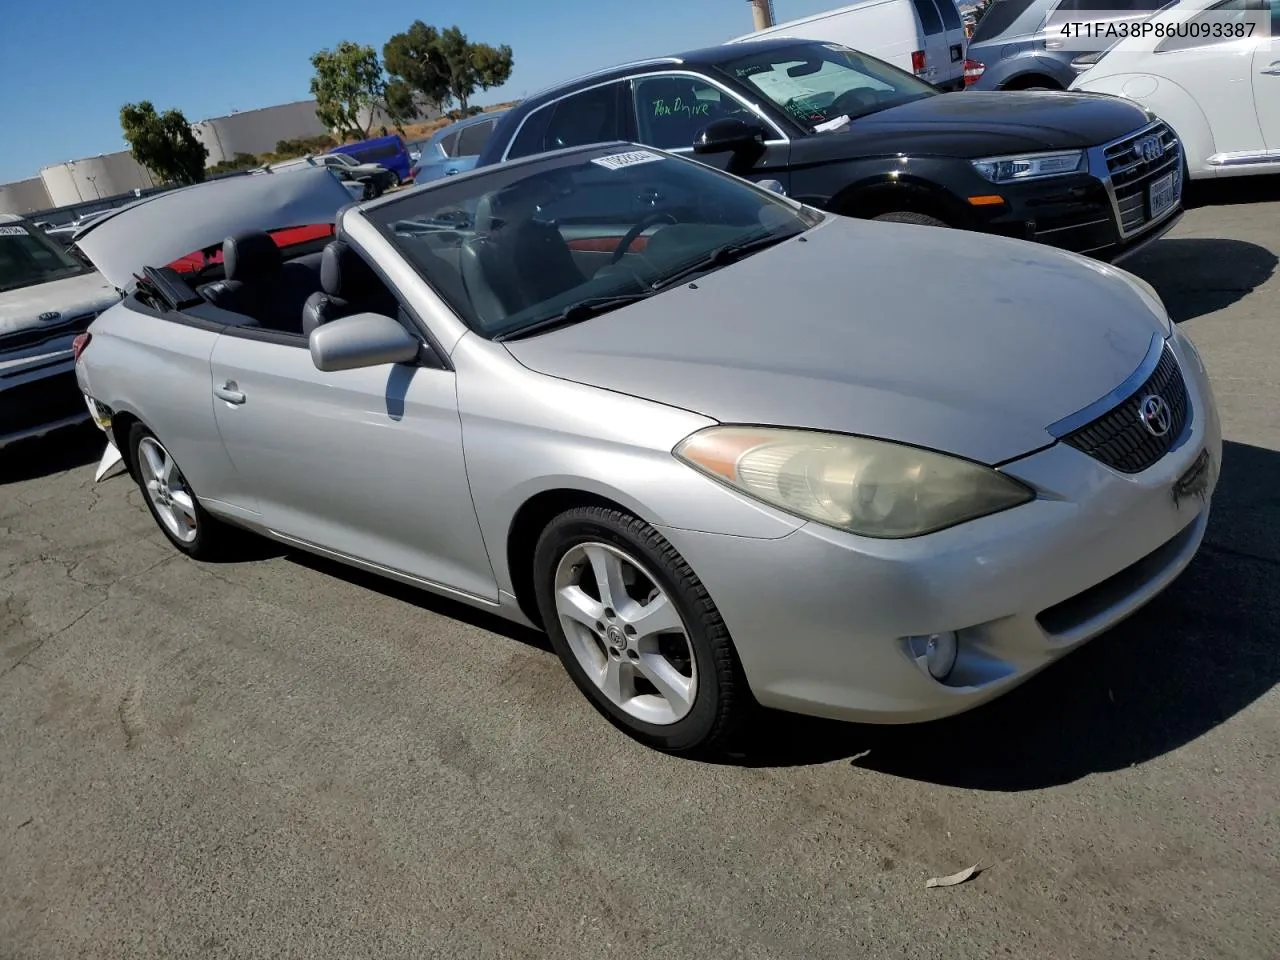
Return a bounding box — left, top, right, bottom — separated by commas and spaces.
534, 507, 750, 753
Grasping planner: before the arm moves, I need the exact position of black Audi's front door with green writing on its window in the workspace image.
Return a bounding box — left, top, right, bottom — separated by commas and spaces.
631, 70, 791, 192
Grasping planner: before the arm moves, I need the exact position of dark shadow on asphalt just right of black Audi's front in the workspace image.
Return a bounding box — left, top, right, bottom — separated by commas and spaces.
1121, 237, 1280, 324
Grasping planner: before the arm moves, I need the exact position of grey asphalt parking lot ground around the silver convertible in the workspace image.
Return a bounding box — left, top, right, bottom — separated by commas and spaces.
0, 179, 1280, 960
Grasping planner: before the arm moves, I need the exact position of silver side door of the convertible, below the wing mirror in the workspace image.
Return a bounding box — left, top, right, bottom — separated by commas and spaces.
210, 320, 497, 600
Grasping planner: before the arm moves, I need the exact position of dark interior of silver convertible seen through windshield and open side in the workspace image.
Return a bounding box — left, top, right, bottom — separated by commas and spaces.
162, 166, 787, 342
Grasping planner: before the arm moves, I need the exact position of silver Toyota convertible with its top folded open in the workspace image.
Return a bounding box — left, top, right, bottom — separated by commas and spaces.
77, 143, 1221, 751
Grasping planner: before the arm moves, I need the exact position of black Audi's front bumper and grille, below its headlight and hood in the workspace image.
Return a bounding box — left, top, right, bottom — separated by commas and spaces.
978, 122, 1185, 262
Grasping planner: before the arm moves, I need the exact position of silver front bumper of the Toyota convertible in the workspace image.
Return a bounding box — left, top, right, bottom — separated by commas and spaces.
663, 334, 1222, 723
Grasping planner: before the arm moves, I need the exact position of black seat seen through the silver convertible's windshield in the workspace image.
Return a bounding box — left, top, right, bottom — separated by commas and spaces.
461, 184, 586, 326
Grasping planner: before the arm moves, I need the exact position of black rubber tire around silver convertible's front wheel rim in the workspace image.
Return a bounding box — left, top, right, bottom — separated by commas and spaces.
534, 507, 754, 755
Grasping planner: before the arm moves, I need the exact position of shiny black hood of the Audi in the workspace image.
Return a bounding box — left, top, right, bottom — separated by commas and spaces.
817, 91, 1155, 159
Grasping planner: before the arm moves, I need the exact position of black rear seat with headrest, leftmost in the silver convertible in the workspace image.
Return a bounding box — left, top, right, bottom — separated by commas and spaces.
201, 230, 320, 333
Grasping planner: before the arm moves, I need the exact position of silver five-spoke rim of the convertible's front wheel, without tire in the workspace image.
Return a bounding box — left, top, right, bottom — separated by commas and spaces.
556, 543, 698, 726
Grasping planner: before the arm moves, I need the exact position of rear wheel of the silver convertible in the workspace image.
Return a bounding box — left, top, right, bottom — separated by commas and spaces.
129, 424, 233, 559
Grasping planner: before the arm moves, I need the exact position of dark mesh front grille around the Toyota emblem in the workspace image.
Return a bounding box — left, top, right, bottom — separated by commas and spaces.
1062, 347, 1190, 474
